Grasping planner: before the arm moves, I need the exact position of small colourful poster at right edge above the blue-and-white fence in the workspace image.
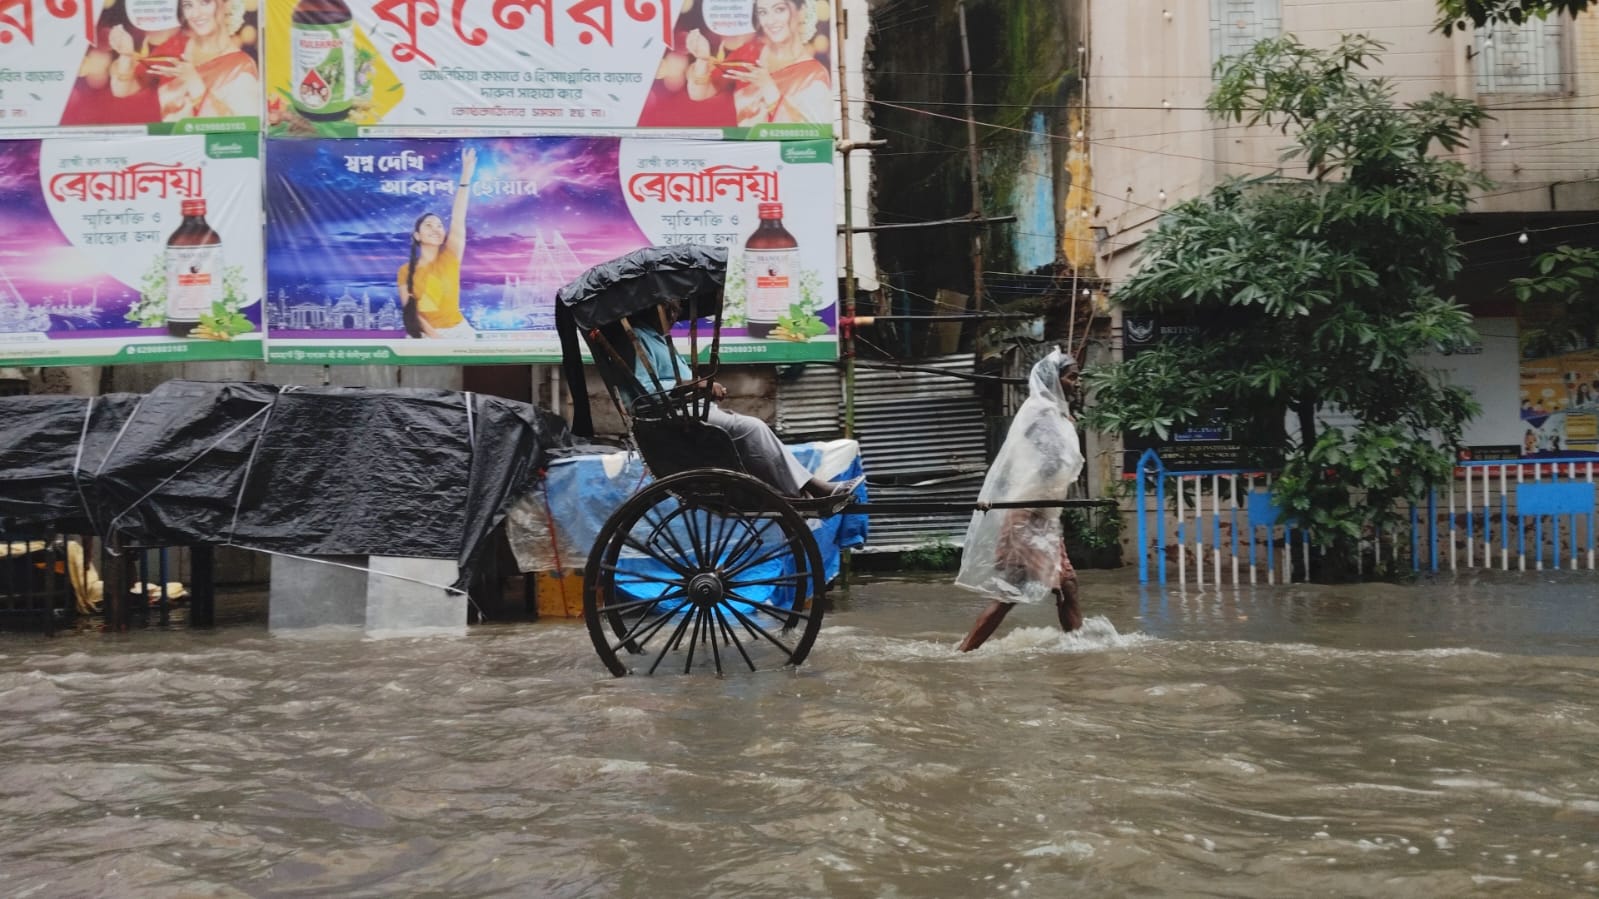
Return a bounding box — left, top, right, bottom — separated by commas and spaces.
1519, 302, 1599, 457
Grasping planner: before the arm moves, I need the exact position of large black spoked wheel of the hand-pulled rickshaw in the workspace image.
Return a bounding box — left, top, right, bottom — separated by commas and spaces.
584, 469, 827, 677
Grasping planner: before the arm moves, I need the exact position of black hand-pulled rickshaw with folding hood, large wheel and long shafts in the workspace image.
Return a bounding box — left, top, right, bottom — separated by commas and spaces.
555, 245, 1083, 677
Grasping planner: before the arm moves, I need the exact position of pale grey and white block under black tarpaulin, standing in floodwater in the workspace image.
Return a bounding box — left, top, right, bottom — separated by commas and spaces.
267, 555, 467, 637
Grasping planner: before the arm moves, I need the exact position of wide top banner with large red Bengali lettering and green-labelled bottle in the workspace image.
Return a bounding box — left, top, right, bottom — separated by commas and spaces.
262, 0, 838, 141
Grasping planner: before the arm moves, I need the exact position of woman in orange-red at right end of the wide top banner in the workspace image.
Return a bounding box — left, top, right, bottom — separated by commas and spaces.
684, 0, 833, 128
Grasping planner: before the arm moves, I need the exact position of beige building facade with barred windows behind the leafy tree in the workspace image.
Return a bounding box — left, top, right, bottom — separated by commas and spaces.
1081, 0, 1599, 454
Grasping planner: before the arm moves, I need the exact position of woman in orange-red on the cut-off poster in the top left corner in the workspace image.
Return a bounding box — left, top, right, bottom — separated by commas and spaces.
110, 0, 261, 122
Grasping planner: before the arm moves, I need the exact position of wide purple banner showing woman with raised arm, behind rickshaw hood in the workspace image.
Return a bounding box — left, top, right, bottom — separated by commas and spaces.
265, 136, 838, 365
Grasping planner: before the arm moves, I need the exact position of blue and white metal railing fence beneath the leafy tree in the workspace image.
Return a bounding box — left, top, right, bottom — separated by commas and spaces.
1135, 450, 1599, 589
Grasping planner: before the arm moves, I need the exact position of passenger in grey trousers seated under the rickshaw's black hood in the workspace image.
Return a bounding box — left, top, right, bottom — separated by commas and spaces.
624, 301, 860, 497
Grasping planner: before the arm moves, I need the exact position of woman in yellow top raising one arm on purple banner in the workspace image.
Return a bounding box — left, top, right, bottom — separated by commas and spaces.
397, 147, 478, 341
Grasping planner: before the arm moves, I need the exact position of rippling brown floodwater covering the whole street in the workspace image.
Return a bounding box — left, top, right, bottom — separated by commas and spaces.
0, 571, 1599, 897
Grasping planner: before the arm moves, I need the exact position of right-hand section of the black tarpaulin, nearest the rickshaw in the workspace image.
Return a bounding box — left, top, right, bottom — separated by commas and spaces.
232, 387, 571, 568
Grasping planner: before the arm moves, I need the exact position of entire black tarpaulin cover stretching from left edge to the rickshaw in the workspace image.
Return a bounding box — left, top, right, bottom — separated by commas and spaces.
0, 381, 572, 582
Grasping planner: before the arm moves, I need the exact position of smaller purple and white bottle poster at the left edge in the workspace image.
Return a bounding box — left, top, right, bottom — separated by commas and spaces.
0, 133, 264, 365
